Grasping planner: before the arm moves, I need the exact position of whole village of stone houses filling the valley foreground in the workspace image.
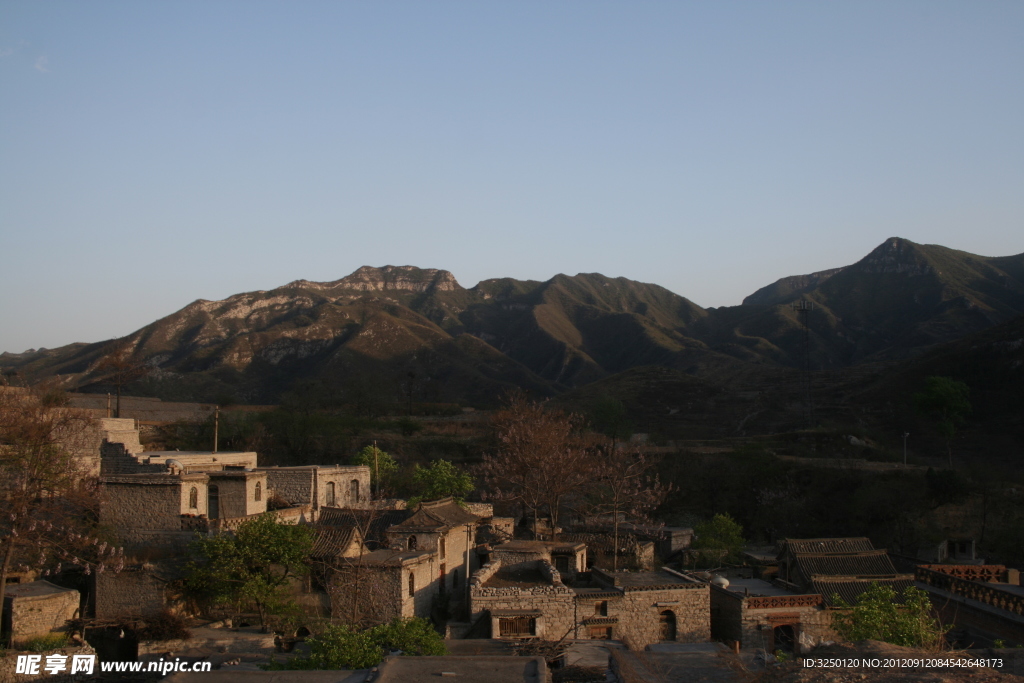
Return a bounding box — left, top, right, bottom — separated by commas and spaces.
0, 389, 1024, 681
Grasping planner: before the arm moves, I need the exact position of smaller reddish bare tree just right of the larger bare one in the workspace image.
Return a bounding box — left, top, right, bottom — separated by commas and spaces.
584, 446, 672, 571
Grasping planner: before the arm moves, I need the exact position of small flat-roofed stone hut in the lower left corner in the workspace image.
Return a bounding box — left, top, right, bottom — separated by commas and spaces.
0, 581, 81, 646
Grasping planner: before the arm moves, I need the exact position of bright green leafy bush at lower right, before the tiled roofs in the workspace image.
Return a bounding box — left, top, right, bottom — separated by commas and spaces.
833, 584, 949, 647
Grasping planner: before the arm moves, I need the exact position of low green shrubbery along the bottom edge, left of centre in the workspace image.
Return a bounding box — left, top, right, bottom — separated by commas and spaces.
269, 616, 447, 670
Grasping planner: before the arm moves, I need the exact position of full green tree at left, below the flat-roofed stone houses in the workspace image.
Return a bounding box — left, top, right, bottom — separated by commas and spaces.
185, 512, 312, 628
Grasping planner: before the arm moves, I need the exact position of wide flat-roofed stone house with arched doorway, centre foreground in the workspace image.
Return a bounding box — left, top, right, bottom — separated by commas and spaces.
470, 556, 711, 648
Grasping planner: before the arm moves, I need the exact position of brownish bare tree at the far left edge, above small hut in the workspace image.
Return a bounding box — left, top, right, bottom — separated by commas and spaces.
0, 387, 123, 626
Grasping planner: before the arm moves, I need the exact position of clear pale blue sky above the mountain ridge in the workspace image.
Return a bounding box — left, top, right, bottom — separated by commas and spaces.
0, 0, 1024, 352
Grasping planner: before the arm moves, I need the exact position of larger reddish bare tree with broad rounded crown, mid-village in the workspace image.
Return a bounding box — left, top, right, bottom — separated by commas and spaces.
481, 392, 595, 540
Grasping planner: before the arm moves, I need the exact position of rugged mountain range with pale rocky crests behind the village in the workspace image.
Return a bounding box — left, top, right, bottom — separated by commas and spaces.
0, 239, 1024, 403
